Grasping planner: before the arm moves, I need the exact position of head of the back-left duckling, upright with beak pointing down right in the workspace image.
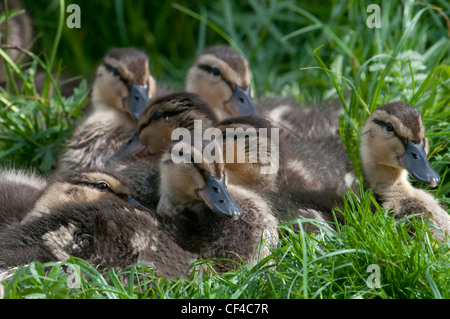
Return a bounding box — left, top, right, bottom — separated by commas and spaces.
92, 48, 156, 120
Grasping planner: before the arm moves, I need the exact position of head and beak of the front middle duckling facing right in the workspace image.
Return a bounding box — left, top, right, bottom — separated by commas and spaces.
157, 141, 242, 219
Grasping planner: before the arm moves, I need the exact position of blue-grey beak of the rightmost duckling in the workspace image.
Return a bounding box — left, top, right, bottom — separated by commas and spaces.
399, 140, 441, 187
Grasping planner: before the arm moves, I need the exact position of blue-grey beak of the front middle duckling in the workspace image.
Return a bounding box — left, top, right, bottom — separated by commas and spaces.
197, 174, 242, 219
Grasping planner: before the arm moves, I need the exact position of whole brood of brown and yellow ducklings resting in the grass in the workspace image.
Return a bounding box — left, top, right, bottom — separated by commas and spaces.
0, 45, 450, 277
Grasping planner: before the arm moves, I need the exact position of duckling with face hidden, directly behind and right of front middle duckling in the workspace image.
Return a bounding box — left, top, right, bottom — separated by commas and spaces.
216, 116, 354, 229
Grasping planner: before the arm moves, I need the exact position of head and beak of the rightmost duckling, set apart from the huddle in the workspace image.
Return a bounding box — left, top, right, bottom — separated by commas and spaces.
361, 102, 440, 187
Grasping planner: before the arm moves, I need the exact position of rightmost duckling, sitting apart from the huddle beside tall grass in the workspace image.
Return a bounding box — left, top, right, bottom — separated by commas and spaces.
360, 102, 450, 239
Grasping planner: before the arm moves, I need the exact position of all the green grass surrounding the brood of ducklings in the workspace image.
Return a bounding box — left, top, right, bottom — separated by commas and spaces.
0, 0, 450, 299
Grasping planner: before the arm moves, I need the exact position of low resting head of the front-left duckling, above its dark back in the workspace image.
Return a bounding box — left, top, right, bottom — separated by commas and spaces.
24, 171, 151, 220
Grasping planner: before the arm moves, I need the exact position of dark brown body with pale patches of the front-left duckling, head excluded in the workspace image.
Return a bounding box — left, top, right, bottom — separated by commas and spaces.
0, 201, 196, 277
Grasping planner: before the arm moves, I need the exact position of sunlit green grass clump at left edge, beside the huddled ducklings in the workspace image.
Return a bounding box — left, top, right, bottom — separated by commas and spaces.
0, 0, 87, 173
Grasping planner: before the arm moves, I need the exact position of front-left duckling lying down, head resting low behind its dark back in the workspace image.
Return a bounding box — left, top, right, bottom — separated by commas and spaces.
0, 171, 196, 277
